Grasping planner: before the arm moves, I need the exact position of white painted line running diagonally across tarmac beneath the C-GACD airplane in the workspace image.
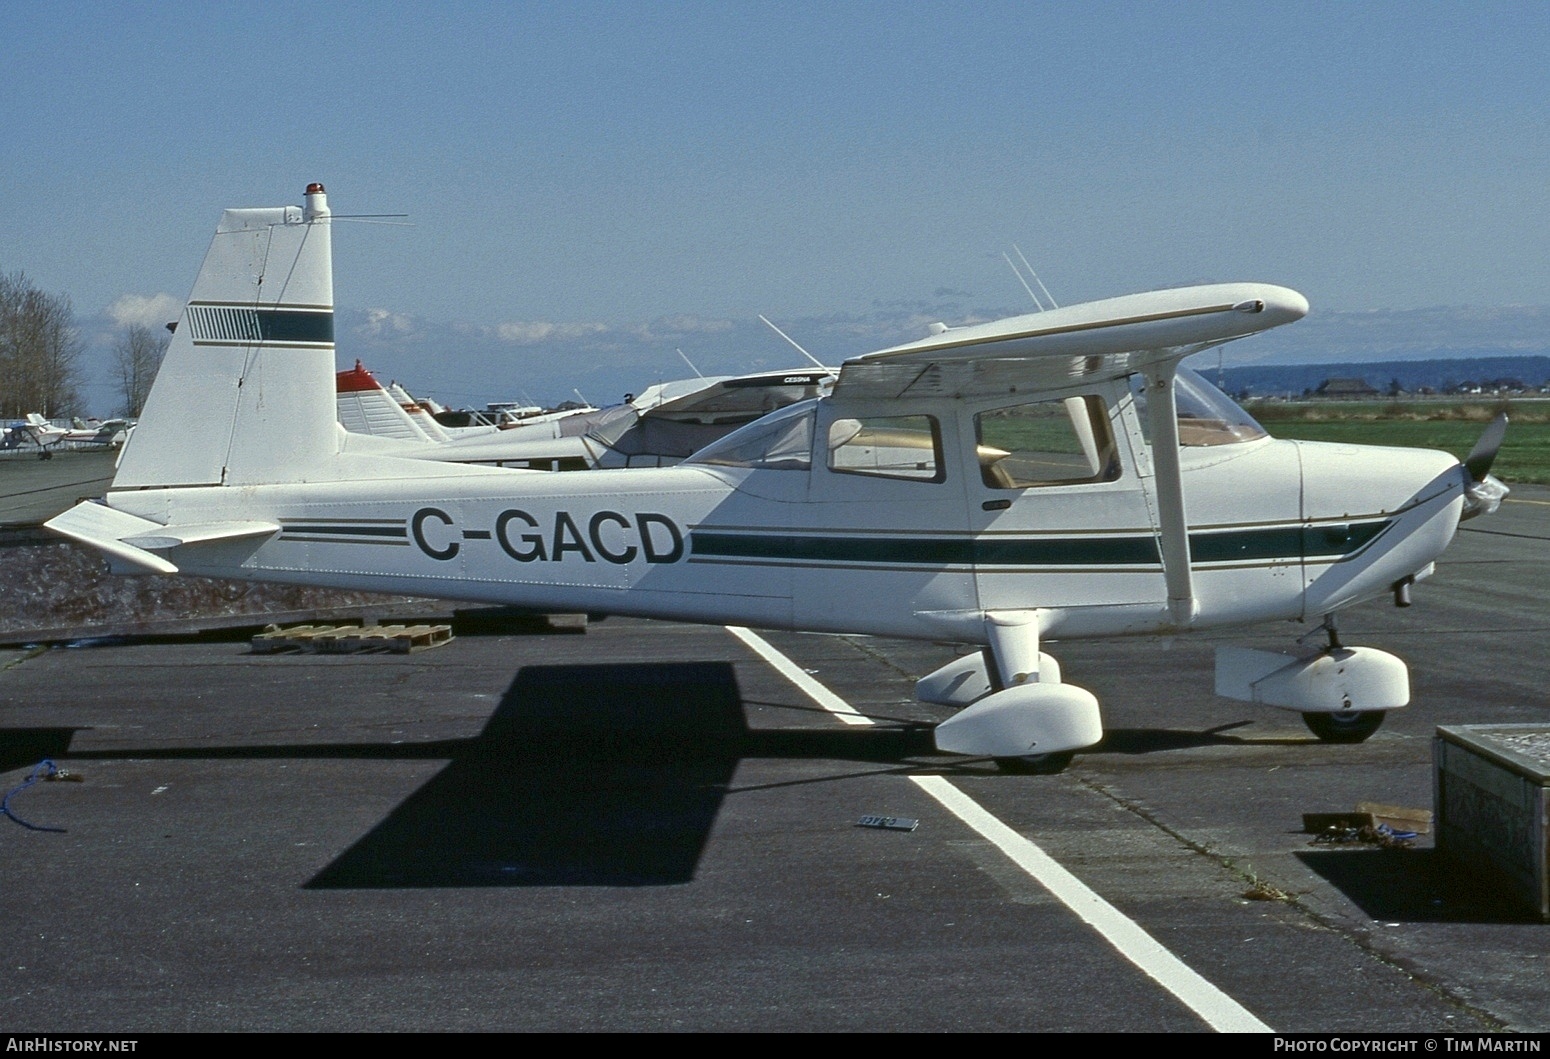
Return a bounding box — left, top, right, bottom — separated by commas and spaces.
727, 625, 1274, 1033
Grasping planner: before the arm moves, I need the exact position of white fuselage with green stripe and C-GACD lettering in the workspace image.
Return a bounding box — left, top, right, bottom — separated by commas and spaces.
99, 370, 1466, 642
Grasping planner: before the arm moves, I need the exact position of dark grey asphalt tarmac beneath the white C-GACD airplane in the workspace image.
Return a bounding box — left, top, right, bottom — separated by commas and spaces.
0, 487, 1550, 1036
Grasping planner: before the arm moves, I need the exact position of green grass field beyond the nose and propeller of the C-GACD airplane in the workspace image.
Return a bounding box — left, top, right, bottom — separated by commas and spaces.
1245, 400, 1550, 485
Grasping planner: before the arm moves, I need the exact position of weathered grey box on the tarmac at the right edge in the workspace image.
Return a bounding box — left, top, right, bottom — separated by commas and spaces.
1432, 724, 1550, 923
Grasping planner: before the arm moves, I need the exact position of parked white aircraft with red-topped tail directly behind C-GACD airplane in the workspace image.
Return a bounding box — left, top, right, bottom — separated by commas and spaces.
336, 361, 837, 471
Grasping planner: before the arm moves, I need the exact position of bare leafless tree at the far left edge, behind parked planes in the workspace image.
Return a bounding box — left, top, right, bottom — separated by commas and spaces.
0, 273, 82, 419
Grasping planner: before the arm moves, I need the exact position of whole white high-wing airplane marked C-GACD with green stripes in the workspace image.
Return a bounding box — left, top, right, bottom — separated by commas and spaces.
48, 185, 1505, 771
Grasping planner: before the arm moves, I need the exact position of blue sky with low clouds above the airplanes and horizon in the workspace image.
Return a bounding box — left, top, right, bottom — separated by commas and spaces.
0, 2, 1550, 412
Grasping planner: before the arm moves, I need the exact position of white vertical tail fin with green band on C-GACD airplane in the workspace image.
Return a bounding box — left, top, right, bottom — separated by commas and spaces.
113, 185, 341, 490
